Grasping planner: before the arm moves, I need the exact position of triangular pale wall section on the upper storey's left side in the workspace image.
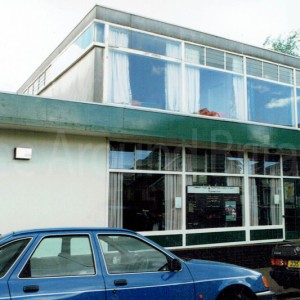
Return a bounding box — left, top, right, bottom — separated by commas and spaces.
40, 48, 96, 102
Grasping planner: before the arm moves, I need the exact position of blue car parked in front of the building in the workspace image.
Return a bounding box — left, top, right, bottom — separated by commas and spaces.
0, 228, 272, 300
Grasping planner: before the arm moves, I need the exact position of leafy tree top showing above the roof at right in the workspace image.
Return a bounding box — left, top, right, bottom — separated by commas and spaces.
263, 31, 300, 56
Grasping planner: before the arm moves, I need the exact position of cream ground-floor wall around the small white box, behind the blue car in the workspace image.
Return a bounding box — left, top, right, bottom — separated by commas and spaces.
0, 130, 108, 233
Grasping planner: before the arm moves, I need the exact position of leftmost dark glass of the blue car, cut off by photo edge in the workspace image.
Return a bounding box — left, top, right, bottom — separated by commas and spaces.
0, 238, 30, 278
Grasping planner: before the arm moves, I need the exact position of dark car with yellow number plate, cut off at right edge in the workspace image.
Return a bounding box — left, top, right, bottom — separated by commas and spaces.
270, 241, 300, 288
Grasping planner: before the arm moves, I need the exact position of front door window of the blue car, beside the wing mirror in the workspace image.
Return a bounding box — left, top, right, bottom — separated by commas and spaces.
98, 235, 168, 274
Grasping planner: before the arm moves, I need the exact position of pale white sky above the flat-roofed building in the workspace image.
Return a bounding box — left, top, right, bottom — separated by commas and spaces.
0, 0, 300, 93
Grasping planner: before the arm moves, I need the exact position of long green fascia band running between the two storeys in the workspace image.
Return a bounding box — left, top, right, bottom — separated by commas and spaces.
0, 93, 300, 150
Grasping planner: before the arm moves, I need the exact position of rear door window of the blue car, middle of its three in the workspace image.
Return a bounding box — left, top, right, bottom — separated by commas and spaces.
20, 236, 95, 278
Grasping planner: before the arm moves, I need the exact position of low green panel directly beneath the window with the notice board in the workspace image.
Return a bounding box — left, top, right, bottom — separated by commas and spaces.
186, 231, 246, 246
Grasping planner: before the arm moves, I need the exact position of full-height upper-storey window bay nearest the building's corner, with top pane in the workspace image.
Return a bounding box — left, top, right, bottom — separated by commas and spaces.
108, 27, 182, 111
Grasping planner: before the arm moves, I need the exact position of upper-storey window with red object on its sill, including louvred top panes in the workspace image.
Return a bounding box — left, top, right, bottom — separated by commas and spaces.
185, 44, 245, 120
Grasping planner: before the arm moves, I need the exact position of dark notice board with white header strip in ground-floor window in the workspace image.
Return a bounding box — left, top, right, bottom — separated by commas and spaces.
186, 186, 242, 229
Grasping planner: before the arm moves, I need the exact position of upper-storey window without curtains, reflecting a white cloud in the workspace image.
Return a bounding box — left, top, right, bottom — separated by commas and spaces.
247, 58, 295, 126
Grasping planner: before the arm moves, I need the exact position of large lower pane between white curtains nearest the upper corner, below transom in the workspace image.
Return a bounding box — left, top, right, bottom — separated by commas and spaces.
109, 50, 181, 111
